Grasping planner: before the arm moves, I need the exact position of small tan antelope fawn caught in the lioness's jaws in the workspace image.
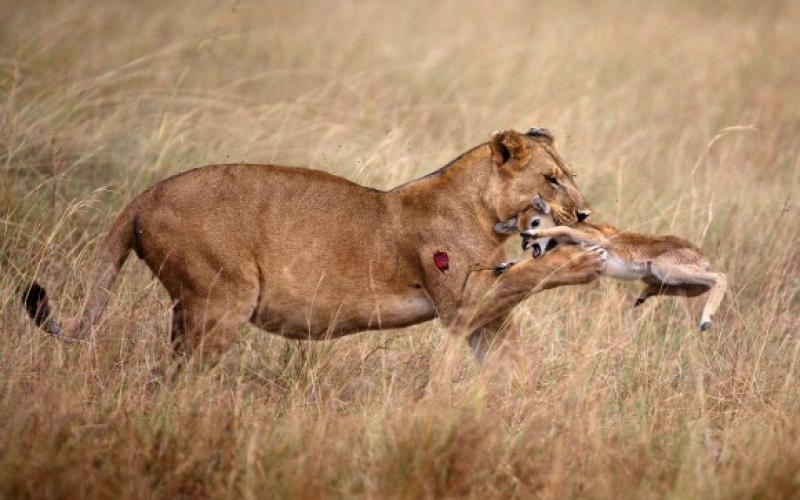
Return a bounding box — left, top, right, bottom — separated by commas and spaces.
496, 196, 727, 331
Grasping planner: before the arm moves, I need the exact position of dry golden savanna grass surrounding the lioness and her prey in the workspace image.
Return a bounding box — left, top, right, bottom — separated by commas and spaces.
0, 0, 800, 498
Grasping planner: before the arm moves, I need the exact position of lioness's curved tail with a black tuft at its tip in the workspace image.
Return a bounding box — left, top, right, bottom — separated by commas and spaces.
22, 197, 141, 339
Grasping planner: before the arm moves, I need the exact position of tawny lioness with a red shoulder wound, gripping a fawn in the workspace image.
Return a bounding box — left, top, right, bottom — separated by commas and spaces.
24, 129, 602, 364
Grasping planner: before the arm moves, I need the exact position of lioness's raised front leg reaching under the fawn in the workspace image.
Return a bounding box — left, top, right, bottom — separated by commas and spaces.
441, 243, 607, 353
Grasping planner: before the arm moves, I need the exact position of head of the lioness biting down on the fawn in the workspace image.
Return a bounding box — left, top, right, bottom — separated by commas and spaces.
484, 128, 591, 225
